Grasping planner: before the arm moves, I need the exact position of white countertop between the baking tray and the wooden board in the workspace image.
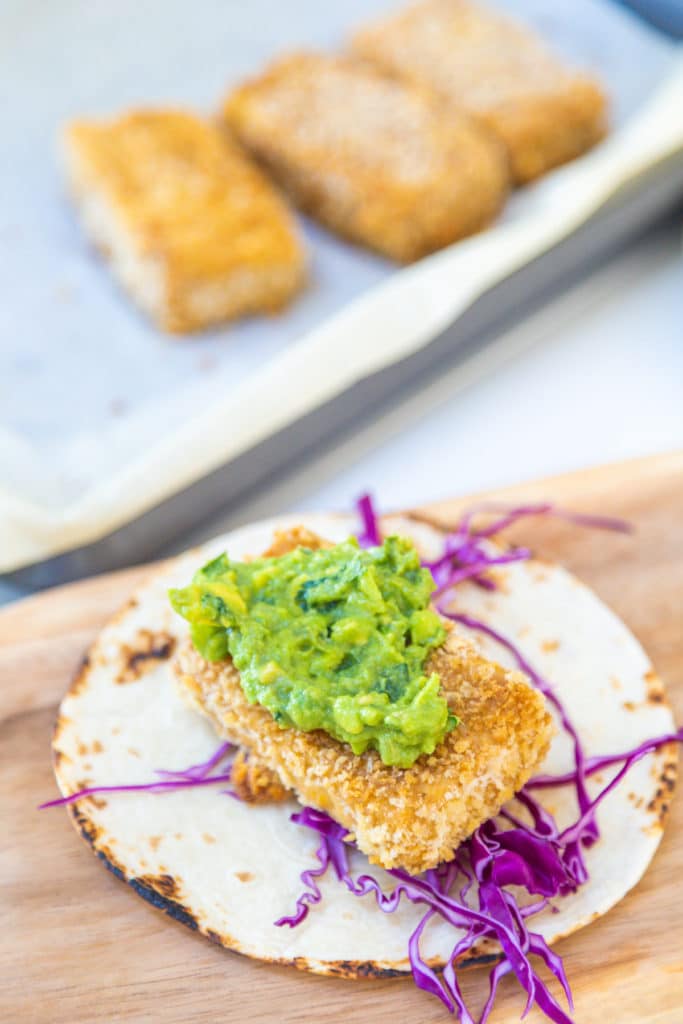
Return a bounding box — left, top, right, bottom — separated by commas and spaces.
0, 213, 683, 602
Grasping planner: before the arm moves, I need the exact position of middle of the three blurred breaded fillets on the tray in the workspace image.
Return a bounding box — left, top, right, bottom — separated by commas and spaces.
224, 53, 508, 261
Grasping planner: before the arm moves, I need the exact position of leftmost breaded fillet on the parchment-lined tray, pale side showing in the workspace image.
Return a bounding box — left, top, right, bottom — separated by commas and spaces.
65, 111, 305, 332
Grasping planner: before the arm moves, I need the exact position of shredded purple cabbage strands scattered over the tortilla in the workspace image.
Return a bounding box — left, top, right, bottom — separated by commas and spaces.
41, 495, 683, 1024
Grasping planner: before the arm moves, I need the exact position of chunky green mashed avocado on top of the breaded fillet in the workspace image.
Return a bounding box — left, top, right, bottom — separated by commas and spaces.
170, 537, 457, 768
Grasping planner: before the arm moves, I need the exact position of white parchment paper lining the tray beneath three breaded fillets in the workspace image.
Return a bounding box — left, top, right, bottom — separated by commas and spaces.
0, 0, 683, 569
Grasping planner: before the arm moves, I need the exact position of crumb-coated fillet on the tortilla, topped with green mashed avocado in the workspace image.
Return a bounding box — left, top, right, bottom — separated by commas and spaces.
176, 531, 553, 872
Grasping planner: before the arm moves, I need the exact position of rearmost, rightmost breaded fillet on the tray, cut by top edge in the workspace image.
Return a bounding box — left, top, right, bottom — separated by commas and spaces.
352, 0, 607, 183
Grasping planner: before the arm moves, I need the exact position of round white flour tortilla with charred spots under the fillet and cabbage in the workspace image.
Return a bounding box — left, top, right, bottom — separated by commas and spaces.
53, 516, 676, 977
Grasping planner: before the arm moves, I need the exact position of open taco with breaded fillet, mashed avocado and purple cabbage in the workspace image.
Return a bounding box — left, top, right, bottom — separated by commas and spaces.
46, 510, 677, 1021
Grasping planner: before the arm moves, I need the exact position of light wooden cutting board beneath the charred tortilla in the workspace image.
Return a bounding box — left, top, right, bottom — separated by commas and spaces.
0, 453, 683, 1024
